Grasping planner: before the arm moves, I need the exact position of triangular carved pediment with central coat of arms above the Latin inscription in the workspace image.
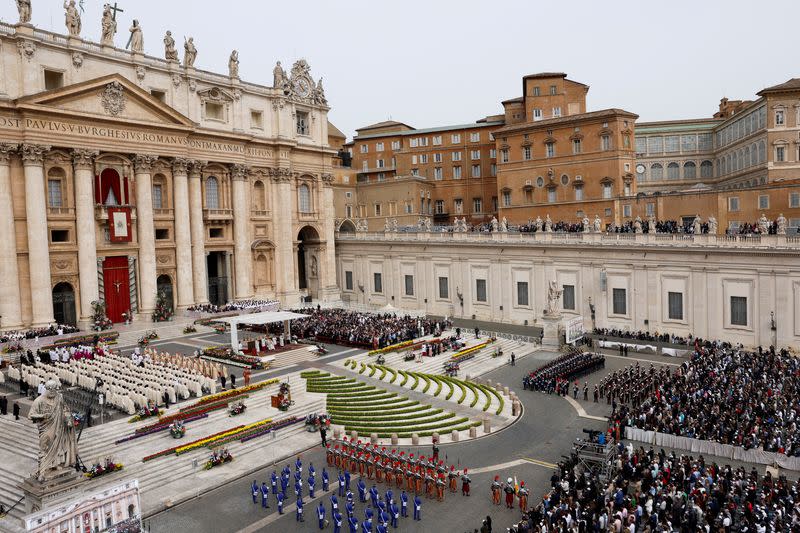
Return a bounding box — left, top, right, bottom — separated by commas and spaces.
16, 74, 194, 127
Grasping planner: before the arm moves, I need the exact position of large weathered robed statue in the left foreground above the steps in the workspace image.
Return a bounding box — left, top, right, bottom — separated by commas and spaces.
28, 381, 78, 481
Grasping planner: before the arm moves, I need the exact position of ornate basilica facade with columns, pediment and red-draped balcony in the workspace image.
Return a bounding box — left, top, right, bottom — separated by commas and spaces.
0, 16, 338, 329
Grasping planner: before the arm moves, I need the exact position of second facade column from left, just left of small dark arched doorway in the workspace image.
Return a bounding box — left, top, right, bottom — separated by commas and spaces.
22, 144, 53, 327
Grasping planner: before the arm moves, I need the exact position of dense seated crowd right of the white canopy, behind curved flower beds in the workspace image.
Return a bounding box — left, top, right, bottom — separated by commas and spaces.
255, 308, 451, 349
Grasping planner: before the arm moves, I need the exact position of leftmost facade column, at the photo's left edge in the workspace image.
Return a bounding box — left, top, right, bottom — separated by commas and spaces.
0, 143, 22, 331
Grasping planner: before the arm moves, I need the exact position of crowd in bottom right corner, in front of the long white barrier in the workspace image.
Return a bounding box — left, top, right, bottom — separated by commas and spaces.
525, 444, 800, 533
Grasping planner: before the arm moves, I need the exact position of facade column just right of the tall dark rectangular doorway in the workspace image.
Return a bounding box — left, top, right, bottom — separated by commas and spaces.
231, 165, 253, 300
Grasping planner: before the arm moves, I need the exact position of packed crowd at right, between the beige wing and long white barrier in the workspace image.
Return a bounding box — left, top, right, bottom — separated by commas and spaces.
615, 344, 800, 457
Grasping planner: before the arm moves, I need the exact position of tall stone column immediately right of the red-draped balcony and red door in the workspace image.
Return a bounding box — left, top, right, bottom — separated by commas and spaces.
133, 154, 158, 320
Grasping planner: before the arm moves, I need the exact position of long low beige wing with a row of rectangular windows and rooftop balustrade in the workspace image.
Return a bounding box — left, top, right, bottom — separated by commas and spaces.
336, 232, 800, 346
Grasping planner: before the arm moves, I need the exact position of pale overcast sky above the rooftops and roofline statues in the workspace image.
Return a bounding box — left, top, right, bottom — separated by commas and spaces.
0, 0, 800, 138
